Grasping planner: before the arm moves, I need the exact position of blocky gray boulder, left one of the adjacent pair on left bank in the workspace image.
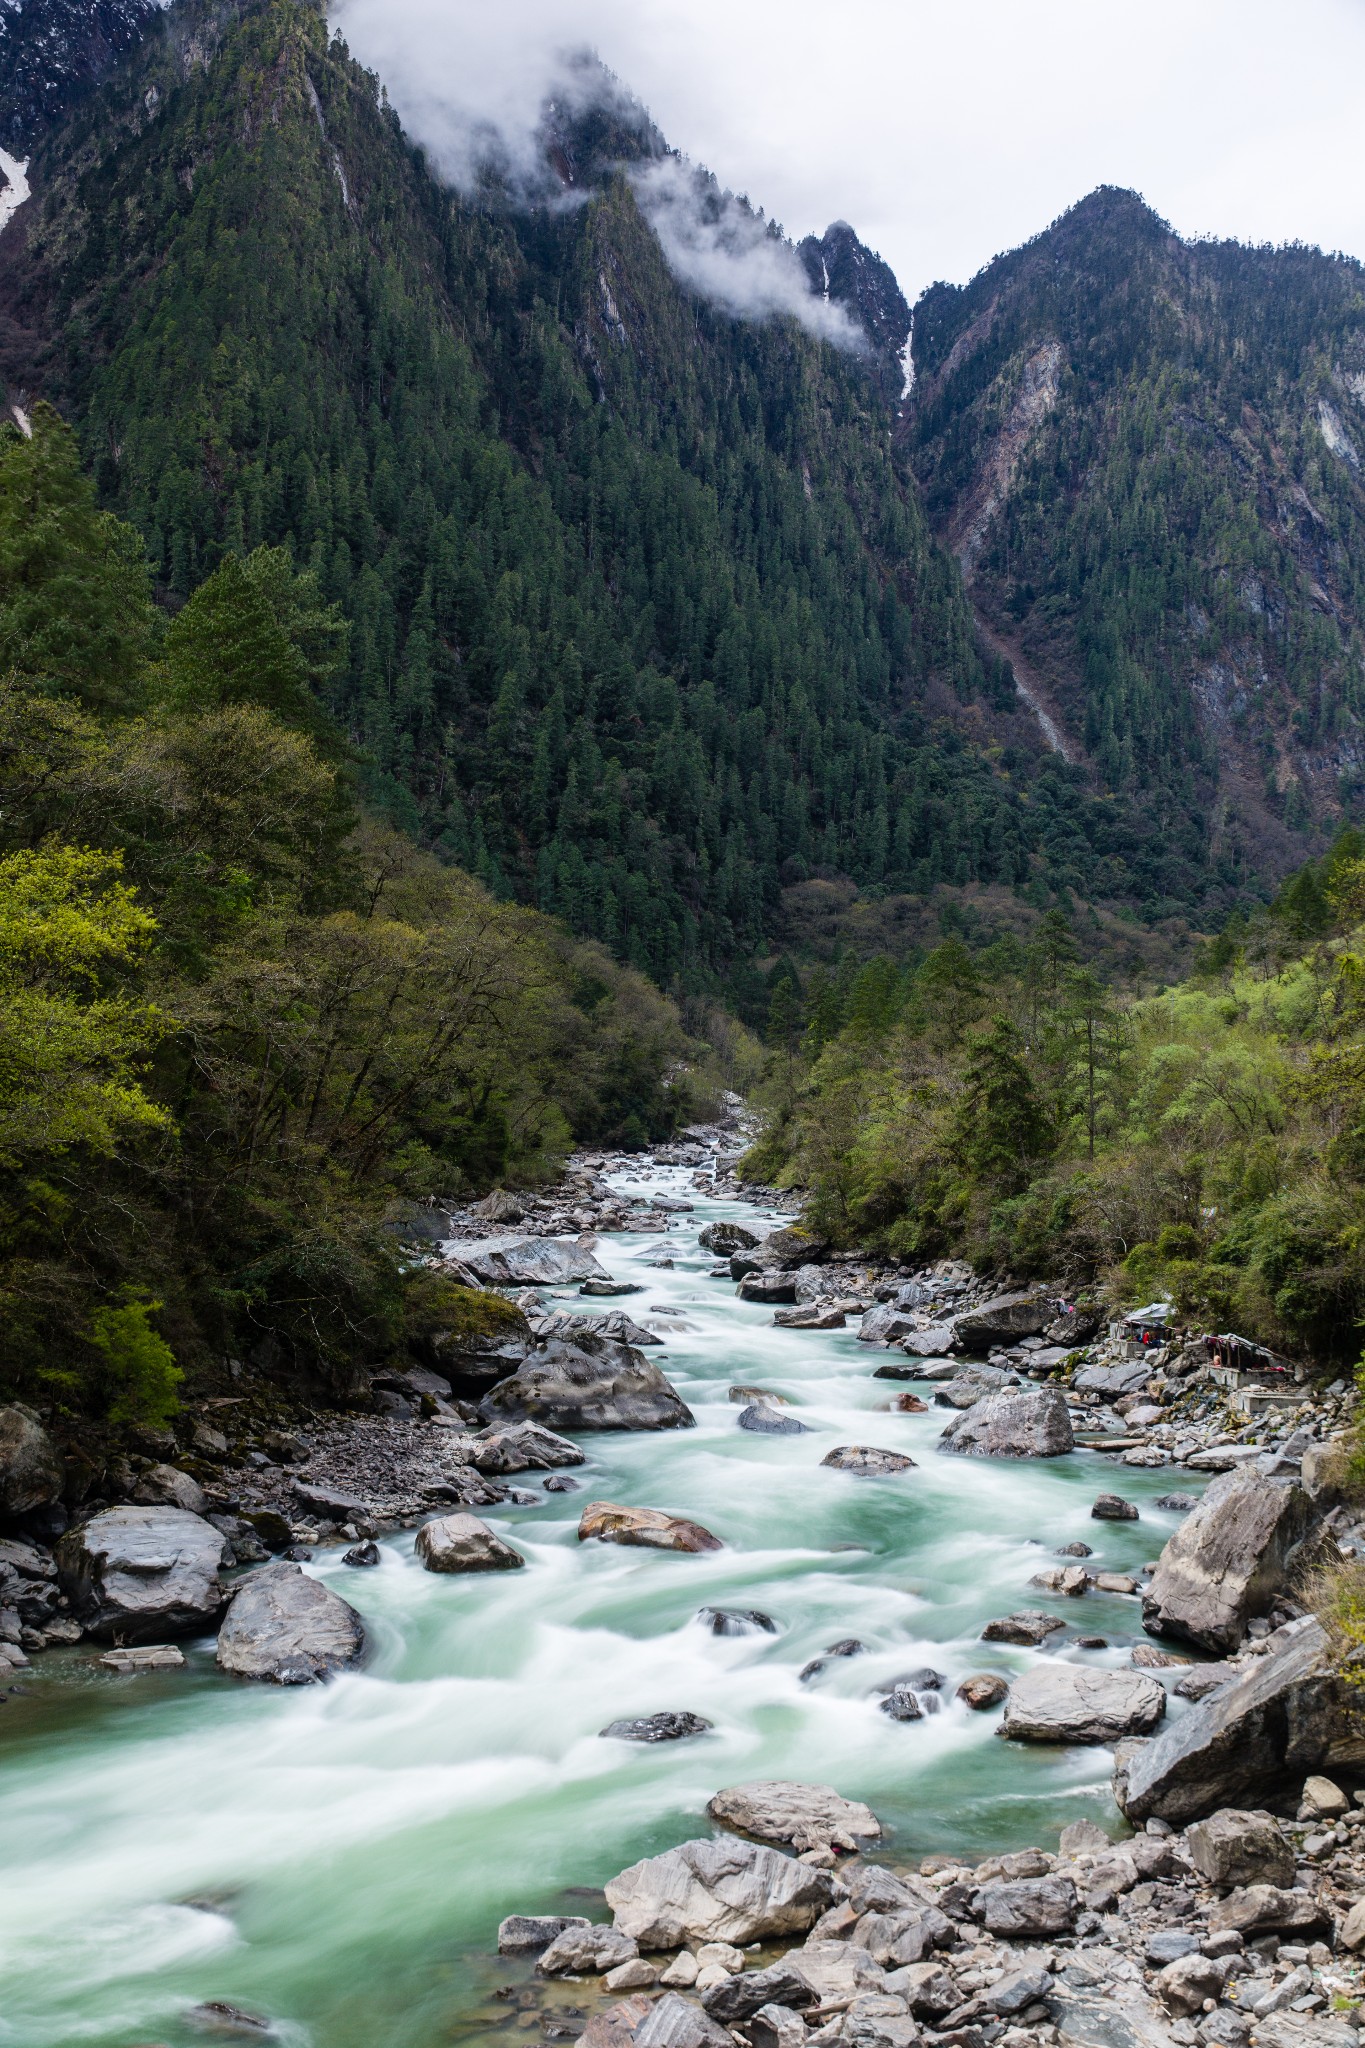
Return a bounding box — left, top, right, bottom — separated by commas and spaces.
55, 1507, 227, 1642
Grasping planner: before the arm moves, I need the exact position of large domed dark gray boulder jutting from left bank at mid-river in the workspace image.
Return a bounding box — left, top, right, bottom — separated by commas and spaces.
481, 1329, 696, 1430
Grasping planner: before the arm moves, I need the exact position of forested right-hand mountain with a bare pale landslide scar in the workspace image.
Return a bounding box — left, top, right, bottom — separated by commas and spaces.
898, 188, 1365, 897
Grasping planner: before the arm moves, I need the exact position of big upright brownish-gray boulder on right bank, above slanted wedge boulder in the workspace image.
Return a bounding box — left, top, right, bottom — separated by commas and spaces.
1142, 1470, 1314, 1655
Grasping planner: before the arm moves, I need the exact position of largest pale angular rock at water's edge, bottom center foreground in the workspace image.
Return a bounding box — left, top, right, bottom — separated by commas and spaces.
606, 1837, 835, 1950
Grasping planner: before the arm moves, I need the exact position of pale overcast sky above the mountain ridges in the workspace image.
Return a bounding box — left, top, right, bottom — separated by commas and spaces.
334, 0, 1365, 299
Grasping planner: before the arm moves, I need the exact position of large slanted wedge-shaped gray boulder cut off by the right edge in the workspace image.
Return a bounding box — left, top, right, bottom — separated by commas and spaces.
1113, 1616, 1365, 1825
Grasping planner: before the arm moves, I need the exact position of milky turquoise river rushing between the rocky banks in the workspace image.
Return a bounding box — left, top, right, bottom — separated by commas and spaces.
0, 1169, 1175, 2048
